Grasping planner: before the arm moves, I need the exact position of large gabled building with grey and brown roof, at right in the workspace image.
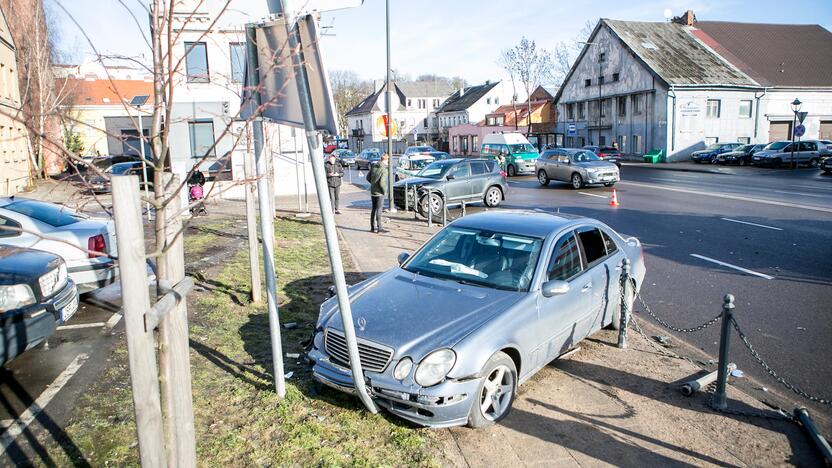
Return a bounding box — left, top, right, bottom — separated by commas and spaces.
556, 12, 832, 160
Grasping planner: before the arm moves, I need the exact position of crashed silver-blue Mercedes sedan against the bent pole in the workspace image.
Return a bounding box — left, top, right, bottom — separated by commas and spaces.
309, 211, 645, 428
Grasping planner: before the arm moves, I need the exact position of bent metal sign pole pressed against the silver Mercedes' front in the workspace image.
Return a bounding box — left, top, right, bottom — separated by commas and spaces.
269, 0, 378, 413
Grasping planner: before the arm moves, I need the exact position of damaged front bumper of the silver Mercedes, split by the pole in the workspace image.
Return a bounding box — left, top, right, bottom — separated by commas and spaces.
308, 347, 481, 428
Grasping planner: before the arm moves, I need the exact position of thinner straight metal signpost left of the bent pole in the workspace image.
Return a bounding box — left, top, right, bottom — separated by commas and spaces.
246, 26, 286, 398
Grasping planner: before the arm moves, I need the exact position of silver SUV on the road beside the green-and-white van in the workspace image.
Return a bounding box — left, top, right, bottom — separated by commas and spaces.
535, 148, 621, 189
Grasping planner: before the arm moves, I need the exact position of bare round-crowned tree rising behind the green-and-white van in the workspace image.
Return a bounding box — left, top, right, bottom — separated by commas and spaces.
501, 36, 554, 133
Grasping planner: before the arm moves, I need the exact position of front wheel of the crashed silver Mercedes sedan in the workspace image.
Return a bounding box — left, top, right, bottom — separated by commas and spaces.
468, 351, 517, 429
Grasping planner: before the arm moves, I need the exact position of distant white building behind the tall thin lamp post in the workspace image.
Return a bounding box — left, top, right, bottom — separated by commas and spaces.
347, 80, 453, 152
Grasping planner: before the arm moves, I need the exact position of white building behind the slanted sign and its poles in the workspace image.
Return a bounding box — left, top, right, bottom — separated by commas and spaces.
162, 0, 314, 195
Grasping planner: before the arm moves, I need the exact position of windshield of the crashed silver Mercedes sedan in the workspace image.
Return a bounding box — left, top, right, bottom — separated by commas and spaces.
403, 226, 543, 291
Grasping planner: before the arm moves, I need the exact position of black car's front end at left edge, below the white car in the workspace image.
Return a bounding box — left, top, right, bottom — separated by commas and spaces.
0, 245, 78, 364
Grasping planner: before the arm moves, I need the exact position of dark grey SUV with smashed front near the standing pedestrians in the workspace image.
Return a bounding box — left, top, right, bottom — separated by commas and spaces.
393, 159, 508, 219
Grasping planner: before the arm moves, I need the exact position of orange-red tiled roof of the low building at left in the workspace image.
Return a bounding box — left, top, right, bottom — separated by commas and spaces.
58, 78, 153, 106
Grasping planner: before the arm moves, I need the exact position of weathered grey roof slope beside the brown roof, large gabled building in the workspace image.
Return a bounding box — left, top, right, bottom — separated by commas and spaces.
601, 19, 759, 87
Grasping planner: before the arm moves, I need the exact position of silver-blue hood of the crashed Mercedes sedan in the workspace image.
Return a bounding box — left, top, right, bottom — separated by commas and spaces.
319, 267, 524, 359
